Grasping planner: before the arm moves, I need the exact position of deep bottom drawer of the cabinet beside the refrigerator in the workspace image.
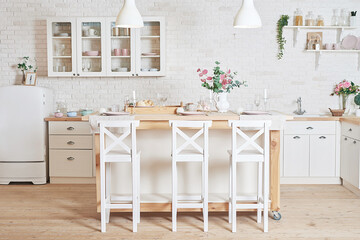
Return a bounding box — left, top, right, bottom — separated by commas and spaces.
49, 150, 93, 177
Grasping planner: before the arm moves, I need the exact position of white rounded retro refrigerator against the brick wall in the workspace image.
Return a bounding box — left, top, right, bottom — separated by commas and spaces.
0, 86, 53, 184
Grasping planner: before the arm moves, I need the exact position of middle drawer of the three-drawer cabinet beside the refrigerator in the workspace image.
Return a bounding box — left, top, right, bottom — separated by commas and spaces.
49, 135, 93, 149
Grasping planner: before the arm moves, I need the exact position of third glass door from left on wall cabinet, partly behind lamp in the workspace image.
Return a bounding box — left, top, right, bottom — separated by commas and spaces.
106, 18, 135, 76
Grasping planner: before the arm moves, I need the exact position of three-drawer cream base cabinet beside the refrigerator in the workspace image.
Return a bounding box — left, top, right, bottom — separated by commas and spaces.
49, 121, 95, 183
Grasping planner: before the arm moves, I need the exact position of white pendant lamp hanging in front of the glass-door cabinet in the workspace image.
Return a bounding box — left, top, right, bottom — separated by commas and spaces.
115, 0, 144, 28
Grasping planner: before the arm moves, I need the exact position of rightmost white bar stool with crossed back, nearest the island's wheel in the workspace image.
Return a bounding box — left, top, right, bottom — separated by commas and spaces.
228, 120, 271, 232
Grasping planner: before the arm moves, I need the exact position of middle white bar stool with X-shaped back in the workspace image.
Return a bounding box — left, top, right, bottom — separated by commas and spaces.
169, 121, 212, 232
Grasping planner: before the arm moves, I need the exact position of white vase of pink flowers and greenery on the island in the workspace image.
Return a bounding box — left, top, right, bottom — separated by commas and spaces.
197, 61, 246, 113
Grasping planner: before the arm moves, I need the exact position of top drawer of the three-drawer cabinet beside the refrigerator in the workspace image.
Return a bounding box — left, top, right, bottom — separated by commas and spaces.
49, 121, 91, 134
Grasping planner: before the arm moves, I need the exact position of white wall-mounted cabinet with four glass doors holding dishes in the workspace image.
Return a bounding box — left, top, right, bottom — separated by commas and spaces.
47, 17, 165, 77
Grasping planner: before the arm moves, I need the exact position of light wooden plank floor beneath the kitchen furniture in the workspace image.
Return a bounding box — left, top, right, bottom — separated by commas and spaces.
0, 185, 360, 240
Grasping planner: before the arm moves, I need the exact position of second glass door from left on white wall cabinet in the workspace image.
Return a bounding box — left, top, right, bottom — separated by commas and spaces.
77, 18, 106, 76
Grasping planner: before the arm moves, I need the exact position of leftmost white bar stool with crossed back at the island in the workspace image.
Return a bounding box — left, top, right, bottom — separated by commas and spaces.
98, 121, 140, 232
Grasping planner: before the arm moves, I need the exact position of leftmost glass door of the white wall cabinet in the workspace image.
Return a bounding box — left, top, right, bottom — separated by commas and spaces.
47, 19, 76, 76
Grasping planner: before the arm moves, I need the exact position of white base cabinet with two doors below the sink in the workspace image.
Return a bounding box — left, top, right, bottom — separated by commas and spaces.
281, 121, 340, 184
